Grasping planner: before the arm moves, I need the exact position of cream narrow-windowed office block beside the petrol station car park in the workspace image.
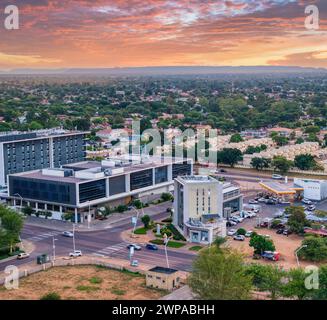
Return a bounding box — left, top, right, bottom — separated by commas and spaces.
173, 175, 243, 244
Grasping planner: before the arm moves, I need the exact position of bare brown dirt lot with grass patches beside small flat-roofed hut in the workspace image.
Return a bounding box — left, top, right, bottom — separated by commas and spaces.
0, 266, 165, 300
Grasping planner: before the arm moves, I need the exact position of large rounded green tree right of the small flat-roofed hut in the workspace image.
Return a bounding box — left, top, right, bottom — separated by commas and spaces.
188, 246, 252, 300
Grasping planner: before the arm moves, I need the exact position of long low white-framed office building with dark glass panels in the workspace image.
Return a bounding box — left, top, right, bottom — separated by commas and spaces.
8, 156, 193, 222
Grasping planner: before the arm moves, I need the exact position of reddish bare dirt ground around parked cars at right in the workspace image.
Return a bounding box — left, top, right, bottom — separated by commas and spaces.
228, 229, 312, 269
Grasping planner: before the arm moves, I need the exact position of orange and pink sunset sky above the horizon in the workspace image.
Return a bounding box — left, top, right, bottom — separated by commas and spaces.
0, 0, 327, 69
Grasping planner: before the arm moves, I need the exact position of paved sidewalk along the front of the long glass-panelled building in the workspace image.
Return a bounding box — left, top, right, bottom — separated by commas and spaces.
25, 201, 172, 232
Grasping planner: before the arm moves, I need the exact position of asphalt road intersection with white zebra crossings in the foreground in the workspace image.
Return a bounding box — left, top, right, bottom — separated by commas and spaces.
0, 212, 196, 271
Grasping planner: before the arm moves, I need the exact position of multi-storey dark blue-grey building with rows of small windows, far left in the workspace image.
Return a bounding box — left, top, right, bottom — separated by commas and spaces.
0, 129, 87, 186
